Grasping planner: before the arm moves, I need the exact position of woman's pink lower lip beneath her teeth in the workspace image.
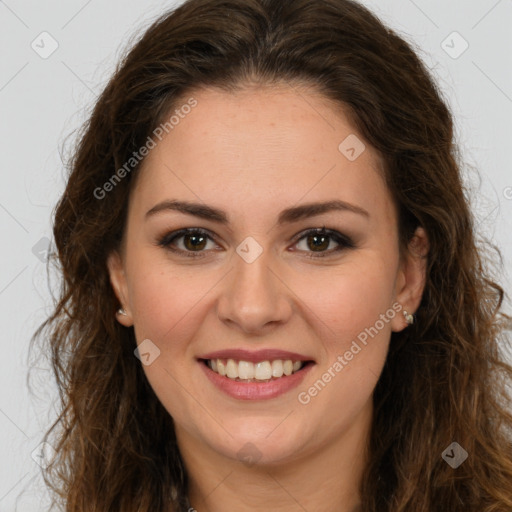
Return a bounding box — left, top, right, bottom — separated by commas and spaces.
199, 361, 314, 400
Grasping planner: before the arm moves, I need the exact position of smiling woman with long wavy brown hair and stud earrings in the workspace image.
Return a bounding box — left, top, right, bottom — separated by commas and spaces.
34, 0, 512, 512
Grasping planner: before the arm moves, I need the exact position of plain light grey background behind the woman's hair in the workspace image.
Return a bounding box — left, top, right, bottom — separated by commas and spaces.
0, 0, 512, 512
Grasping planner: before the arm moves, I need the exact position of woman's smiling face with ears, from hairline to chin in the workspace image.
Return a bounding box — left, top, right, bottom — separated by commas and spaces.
109, 87, 424, 463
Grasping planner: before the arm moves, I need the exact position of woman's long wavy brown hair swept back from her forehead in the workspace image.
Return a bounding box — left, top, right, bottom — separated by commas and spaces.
34, 0, 512, 512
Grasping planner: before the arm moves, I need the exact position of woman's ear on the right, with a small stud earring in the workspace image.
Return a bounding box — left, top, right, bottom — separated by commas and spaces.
391, 227, 430, 332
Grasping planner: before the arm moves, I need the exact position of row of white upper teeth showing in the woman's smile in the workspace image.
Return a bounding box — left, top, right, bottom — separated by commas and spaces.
207, 359, 304, 381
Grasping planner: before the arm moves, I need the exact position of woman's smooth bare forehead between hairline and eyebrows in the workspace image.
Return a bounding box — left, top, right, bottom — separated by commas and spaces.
128, 86, 391, 230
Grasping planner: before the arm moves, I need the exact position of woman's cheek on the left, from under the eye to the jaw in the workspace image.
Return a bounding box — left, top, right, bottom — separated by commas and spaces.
126, 259, 219, 429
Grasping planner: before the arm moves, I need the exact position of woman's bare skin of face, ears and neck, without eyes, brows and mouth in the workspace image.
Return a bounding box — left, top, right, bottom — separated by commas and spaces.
108, 85, 428, 512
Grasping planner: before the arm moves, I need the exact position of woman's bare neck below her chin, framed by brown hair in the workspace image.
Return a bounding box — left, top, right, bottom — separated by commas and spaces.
176, 401, 372, 512
